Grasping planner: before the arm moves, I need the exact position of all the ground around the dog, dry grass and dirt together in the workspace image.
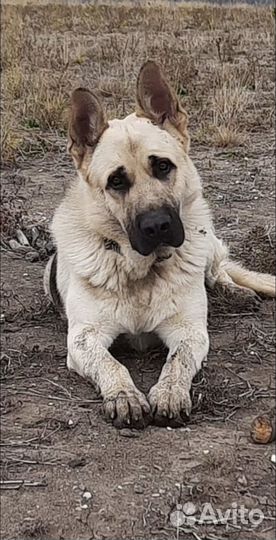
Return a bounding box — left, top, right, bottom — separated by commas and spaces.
0, 1, 275, 540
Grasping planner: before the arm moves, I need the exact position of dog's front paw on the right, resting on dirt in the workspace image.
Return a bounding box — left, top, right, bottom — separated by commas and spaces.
148, 381, 192, 427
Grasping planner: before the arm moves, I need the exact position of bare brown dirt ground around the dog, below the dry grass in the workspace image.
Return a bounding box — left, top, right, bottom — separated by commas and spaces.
1, 1, 275, 540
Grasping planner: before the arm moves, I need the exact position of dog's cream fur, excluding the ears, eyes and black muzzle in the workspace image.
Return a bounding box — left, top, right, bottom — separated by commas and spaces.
46, 62, 275, 427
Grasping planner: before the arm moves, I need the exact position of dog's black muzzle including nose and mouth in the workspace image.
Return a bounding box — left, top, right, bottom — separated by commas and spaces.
129, 206, 185, 256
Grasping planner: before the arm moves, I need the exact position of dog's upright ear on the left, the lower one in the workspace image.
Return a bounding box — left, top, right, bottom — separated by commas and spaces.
68, 88, 107, 169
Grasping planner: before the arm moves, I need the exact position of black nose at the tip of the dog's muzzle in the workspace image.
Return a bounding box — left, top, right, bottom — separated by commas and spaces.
139, 209, 172, 242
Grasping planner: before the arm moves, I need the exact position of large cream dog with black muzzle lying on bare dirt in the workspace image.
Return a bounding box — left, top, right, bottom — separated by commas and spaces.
44, 62, 275, 428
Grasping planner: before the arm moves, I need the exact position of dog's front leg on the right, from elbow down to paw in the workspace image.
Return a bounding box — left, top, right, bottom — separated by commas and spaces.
148, 315, 209, 426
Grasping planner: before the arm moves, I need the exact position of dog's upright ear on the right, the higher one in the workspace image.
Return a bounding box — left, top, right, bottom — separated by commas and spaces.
136, 60, 190, 152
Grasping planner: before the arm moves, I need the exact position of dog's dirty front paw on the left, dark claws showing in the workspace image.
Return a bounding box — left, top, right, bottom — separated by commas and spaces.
103, 388, 151, 429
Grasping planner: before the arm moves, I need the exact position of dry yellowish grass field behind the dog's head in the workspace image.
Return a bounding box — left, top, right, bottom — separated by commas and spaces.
1, 2, 274, 162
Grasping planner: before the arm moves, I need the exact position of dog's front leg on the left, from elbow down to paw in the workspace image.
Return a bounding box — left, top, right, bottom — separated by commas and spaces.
67, 325, 150, 428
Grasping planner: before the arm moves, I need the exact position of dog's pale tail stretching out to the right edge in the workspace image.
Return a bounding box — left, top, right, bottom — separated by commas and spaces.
207, 237, 276, 298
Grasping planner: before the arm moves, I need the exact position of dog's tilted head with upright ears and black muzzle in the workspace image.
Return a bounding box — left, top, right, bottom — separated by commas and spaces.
69, 61, 195, 255
